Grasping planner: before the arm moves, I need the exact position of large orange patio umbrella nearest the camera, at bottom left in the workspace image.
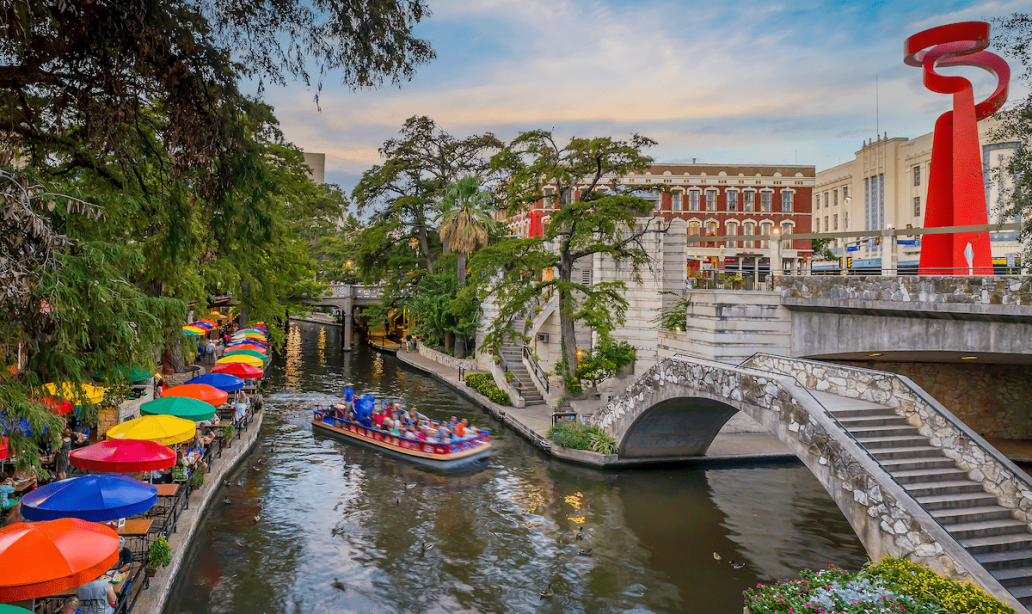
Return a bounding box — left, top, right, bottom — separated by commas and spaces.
0, 518, 119, 602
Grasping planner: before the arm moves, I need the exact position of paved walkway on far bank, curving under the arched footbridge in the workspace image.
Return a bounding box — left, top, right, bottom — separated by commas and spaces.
397, 350, 796, 467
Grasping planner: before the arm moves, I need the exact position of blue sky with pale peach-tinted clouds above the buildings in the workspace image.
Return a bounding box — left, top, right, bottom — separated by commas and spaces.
265, 0, 1032, 192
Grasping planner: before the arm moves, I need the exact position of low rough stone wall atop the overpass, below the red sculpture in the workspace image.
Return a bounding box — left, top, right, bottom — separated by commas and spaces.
775, 276, 1032, 305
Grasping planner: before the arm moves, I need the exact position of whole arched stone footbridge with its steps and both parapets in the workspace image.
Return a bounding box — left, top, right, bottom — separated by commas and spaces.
590, 354, 1032, 613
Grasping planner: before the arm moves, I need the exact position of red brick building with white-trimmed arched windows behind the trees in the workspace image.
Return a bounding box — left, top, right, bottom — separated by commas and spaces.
504, 164, 816, 276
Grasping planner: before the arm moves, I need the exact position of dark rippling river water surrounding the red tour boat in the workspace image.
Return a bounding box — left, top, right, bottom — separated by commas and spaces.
164, 323, 866, 614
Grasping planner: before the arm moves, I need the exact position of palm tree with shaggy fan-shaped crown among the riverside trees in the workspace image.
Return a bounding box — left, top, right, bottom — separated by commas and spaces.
438, 176, 494, 358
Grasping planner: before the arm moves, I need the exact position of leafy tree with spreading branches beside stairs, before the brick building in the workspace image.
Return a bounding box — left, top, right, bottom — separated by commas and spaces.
474, 131, 666, 392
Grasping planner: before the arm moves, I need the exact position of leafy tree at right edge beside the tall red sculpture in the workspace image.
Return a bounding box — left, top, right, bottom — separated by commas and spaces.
990, 13, 1032, 255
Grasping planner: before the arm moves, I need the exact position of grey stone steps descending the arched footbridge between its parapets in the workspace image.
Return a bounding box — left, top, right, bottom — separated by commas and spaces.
811, 391, 1032, 606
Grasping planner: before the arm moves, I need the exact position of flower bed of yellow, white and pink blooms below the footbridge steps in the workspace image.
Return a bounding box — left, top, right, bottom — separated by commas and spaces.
745, 558, 1014, 614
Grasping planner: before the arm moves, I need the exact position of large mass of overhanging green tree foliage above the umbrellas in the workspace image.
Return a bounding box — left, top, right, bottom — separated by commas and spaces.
0, 0, 433, 470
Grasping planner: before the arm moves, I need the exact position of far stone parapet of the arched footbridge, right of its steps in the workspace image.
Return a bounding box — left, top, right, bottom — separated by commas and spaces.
747, 355, 1032, 548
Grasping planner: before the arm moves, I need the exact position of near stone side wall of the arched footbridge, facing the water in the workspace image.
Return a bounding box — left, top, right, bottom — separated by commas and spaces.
589, 356, 1032, 611
